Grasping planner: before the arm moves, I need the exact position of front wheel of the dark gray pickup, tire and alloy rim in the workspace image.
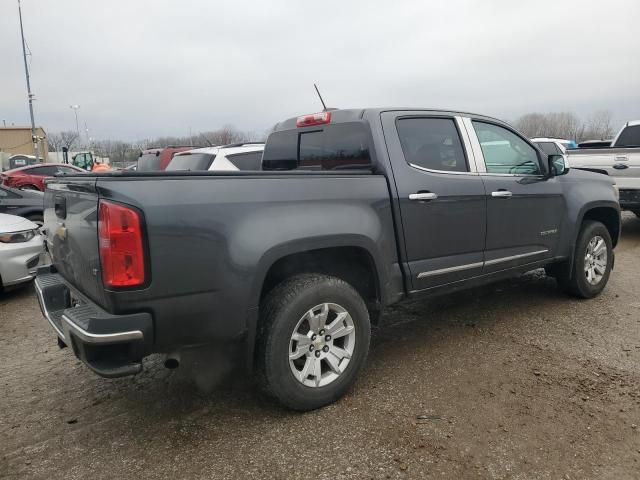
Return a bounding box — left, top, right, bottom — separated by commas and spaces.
557, 220, 613, 298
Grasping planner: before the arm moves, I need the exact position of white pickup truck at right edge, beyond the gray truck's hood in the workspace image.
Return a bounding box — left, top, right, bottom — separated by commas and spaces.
567, 120, 640, 217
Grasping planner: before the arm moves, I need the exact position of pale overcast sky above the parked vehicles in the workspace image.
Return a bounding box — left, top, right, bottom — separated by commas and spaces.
0, 0, 640, 140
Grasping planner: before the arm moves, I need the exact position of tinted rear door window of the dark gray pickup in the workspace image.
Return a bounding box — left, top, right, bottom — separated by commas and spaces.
397, 117, 469, 172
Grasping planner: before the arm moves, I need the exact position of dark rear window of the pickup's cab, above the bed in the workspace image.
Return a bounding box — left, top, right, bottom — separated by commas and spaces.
262, 122, 371, 170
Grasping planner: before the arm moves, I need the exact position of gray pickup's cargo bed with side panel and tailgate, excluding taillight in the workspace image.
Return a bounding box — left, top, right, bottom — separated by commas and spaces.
44, 172, 402, 350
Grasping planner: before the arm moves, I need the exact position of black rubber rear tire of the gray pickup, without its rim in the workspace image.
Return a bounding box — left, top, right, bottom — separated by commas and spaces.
256, 274, 371, 411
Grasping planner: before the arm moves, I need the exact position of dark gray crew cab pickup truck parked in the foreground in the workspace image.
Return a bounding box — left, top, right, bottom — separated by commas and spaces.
36, 108, 620, 410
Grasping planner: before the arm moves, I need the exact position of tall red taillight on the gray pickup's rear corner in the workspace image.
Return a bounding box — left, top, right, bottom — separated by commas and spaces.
98, 200, 144, 287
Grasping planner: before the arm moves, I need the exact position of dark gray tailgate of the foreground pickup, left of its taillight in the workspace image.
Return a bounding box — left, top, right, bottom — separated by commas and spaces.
44, 177, 106, 306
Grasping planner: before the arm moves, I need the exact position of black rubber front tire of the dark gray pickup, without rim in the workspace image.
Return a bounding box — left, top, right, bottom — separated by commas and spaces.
556, 220, 613, 298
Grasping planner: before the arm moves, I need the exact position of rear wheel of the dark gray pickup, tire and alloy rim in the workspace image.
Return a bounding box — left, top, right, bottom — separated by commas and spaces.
256, 275, 371, 411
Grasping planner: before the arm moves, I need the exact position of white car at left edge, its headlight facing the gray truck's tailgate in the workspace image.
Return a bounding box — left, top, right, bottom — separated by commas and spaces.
0, 213, 46, 288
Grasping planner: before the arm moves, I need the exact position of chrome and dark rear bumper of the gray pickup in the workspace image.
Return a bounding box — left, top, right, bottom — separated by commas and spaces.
35, 266, 153, 378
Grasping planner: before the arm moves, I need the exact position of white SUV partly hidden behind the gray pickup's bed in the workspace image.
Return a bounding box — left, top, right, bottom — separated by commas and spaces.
166, 142, 264, 171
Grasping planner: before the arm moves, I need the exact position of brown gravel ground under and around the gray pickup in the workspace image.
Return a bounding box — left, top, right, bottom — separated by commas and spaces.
0, 215, 640, 479
